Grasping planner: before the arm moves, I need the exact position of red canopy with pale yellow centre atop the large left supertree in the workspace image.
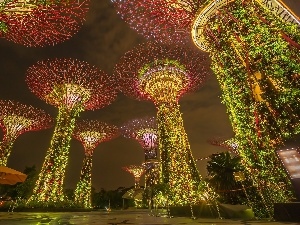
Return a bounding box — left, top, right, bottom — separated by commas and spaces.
26, 59, 117, 110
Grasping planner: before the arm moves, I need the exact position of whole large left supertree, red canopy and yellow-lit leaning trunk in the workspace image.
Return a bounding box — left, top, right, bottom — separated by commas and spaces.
26, 59, 117, 202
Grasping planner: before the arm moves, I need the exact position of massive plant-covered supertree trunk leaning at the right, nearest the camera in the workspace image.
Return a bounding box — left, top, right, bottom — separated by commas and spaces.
200, 1, 300, 216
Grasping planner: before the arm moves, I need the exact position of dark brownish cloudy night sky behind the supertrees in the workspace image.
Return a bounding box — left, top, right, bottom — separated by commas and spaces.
0, 0, 300, 190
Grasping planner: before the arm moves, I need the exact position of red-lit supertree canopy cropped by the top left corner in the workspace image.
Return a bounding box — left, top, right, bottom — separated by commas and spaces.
0, 0, 89, 47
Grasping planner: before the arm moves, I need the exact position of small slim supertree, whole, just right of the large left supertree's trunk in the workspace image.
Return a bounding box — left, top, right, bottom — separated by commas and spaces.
73, 120, 119, 208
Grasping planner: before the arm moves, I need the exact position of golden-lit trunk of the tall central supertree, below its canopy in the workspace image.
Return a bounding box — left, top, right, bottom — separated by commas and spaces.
157, 103, 200, 205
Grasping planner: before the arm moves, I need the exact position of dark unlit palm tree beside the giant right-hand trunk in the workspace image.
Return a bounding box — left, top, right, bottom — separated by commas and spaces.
206, 151, 245, 204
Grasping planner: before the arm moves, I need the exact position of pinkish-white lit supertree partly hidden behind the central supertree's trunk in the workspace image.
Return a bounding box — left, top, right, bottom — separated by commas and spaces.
120, 117, 159, 188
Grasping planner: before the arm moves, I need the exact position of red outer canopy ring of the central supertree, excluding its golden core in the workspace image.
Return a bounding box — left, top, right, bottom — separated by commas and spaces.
115, 42, 209, 103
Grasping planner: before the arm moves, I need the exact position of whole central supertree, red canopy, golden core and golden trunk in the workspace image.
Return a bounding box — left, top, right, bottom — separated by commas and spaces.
115, 43, 207, 205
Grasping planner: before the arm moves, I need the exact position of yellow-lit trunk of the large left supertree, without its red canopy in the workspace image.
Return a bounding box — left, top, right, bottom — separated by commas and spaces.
31, 107, 83, 202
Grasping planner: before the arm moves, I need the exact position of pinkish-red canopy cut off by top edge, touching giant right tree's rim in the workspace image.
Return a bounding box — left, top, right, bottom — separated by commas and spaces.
112, 0, 204, 43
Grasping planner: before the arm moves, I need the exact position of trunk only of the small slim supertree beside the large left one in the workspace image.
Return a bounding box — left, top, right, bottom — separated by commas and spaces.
75, 151, 93, 208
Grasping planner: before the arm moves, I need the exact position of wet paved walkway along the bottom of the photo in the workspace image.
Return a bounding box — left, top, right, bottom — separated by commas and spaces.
0, 210, 300, 225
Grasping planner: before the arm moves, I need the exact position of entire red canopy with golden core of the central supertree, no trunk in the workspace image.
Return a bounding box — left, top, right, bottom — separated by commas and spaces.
115, 42, 208, 105
